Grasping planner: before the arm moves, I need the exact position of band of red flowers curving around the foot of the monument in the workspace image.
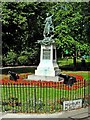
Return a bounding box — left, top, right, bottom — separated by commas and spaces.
0, 74, 86, 90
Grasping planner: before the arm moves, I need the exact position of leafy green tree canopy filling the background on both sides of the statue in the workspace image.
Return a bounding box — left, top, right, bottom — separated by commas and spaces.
2, 2, 90, 64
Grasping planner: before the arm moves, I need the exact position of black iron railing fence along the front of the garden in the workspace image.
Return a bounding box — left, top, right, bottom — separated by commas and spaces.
1, 80, 85, 113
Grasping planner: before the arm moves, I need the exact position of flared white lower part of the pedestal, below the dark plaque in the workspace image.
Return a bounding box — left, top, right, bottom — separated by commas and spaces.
35, 60, 60, 77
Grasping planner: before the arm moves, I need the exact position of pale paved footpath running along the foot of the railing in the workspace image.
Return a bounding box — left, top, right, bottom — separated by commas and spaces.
0, 107, 90, 120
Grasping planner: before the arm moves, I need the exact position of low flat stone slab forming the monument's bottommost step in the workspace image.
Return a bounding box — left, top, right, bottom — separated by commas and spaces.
27, 75, 62, 82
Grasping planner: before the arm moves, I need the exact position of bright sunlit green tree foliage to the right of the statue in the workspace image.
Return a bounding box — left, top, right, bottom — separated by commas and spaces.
54, 3, 90, 55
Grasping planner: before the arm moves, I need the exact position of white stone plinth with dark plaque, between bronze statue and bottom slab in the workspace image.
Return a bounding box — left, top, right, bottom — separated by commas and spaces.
35, 44, 60, 77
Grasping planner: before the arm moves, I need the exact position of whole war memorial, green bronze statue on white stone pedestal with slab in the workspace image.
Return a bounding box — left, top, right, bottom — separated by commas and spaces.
28, 13, 60, 81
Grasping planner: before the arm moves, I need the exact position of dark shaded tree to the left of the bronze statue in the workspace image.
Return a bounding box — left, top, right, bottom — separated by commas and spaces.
2, 2, 52, 65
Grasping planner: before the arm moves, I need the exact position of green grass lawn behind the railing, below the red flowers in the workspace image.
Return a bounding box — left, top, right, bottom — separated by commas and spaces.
2, 81, 87, 113
